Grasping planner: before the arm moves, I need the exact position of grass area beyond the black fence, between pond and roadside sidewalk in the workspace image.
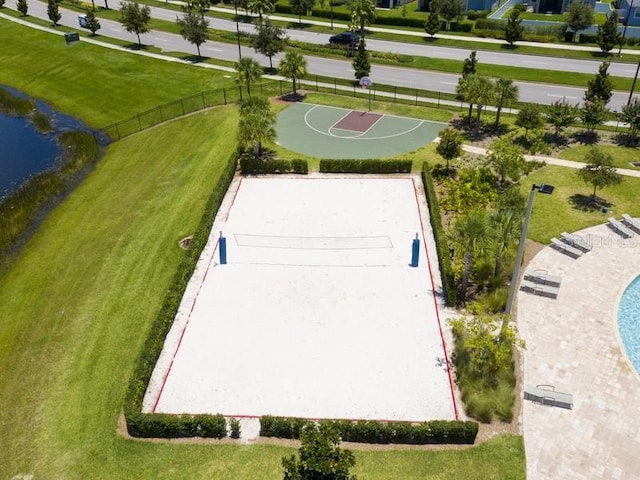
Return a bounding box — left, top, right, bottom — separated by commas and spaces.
0, 22, 234, 127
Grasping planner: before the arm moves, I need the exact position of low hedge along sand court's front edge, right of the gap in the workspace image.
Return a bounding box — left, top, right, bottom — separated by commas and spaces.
260, 415, 478, 445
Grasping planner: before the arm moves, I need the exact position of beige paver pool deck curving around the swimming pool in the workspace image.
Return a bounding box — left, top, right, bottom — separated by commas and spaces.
517, 225, 640, 480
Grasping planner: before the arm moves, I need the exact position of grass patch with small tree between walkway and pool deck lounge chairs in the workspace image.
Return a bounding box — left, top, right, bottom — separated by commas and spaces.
521, 165, 640, 243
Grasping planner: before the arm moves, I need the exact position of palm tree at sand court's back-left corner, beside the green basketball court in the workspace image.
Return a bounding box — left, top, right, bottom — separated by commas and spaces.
238, 96, 276, 157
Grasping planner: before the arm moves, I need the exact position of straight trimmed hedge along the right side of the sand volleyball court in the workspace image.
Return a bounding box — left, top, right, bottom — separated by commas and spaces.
422, 162, 456, 307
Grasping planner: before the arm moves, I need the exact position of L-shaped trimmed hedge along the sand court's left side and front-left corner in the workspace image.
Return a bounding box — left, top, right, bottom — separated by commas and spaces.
123, 153, 237, 438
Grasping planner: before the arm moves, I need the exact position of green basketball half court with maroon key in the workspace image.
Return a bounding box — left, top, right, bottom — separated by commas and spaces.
276, 103, 445, 158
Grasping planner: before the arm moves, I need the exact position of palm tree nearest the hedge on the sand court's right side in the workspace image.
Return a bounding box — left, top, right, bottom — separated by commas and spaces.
452, 211, 490, 303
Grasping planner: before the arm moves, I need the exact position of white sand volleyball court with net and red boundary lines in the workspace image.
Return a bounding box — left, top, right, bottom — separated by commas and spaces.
144, 174, 457, 436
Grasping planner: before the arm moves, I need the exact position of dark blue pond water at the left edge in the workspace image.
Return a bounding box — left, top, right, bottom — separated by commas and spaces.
0, 85, 106, 198
